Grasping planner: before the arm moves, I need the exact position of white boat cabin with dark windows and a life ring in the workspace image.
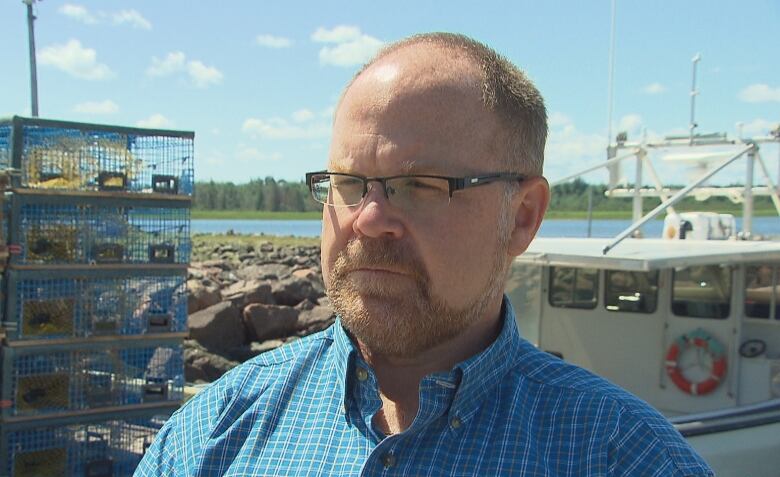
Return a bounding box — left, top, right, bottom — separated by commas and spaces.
507, 238, 780, 416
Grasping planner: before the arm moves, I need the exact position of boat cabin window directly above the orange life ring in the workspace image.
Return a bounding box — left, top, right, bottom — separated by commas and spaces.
672, 265, 731, 318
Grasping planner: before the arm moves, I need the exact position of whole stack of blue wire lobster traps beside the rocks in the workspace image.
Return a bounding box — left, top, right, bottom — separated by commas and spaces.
0, 117, 194, 476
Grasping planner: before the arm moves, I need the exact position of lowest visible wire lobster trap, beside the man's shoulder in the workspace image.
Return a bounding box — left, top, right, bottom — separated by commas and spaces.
0, 408, 173, 477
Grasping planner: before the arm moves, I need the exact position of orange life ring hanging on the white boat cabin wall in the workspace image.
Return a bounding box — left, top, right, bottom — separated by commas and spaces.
665, 328, 728, 396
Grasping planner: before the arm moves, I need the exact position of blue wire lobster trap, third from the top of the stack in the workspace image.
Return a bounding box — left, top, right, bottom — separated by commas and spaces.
2, 268, 187, 340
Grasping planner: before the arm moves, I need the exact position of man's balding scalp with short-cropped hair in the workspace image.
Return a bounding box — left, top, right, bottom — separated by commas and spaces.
340, 33, 547, 175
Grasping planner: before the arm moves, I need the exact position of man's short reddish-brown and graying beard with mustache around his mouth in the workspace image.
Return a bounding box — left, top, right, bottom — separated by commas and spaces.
327, 234, 507, 358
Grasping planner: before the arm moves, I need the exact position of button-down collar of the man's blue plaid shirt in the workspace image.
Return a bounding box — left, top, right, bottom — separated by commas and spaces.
326, 295, 522, 421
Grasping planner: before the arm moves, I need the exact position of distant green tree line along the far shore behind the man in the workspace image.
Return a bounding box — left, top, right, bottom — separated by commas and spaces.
193, 177, 772, 212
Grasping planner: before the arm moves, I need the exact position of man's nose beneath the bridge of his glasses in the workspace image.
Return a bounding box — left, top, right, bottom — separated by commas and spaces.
352, 181, 404, 238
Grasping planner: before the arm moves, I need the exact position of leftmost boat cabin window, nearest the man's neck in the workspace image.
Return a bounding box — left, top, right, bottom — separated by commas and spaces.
550, 267, 599, 309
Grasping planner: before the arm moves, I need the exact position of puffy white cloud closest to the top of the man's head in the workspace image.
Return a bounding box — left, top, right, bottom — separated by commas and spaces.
311, 25, 383, 66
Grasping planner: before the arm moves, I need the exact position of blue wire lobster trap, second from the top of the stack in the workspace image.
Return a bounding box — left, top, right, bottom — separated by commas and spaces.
9, 190, 192, 265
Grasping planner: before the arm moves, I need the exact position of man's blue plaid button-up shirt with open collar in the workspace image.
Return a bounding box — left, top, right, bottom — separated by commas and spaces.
135, 300, 712, 477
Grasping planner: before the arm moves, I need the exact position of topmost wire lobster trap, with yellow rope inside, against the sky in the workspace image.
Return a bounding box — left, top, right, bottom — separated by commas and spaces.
0, 116, 194, 195
